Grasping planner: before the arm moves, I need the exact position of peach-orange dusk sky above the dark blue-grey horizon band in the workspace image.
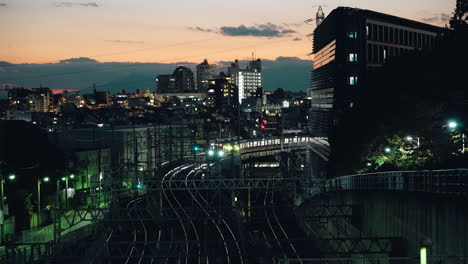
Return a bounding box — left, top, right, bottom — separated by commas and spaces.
0, 0, 455, 63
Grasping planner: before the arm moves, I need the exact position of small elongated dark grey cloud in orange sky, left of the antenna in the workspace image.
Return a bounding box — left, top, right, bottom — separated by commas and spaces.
219, 23, 296, 37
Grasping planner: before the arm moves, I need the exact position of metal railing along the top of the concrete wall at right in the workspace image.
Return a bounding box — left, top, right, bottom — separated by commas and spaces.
325, 169, 468, 195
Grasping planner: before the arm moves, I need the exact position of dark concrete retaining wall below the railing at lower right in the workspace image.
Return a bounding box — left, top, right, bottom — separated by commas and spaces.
308, 192, 468, 263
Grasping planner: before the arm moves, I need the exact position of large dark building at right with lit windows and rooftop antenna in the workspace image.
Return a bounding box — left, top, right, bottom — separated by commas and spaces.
309, 7, 443, 137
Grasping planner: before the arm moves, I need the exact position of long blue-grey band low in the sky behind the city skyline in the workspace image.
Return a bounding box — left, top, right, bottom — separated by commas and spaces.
0, 57, 312, 93
